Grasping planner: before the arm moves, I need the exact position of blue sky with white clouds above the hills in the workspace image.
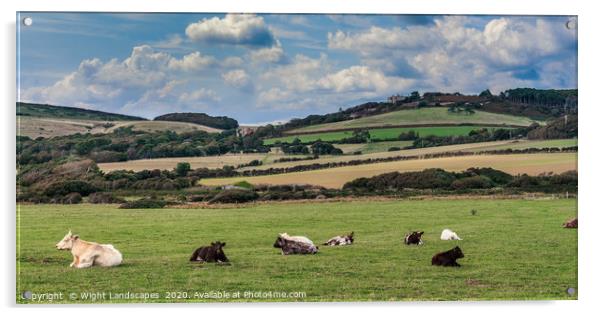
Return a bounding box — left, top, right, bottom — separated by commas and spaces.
17, 12, 577, 124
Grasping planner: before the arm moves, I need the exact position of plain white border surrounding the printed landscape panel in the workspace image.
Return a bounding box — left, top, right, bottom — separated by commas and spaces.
0, 0, 602, 316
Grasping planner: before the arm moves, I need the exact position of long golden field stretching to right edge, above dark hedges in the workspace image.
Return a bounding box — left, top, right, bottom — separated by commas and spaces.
200, 153, 577, 188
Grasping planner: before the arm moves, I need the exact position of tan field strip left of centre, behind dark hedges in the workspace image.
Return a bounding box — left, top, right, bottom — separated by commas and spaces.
98, 153, 283, 172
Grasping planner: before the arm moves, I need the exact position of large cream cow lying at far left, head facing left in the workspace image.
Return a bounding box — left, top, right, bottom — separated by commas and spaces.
56, 231, 122, 268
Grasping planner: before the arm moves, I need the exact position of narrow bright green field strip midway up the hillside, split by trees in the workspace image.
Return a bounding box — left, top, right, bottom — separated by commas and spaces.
263, 126, 510, 145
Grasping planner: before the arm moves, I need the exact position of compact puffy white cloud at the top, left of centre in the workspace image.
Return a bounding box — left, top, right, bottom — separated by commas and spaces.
186, 14, 275, 46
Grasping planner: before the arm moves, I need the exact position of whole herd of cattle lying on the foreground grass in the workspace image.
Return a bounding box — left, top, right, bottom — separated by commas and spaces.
56, 218, 577, 268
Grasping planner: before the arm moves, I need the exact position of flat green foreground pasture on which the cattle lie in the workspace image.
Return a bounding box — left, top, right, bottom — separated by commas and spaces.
17, 199, 577, 303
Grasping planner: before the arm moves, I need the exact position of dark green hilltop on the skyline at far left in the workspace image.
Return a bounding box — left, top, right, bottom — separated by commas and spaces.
17, 102, 146, 121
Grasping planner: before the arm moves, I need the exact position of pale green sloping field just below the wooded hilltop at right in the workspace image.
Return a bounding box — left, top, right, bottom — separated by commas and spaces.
289, 107, 534, 133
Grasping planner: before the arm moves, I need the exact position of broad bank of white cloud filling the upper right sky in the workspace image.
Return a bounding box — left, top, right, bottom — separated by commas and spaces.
328, 16, 576, 92
